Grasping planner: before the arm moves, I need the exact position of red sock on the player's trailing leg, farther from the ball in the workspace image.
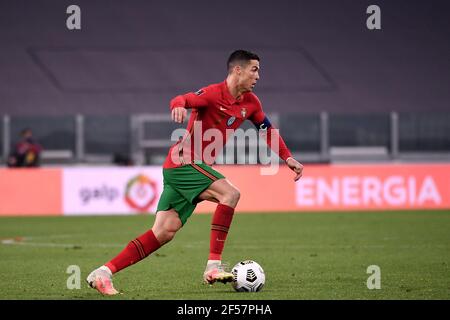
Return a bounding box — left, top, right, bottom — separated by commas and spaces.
105, 229, 161, 273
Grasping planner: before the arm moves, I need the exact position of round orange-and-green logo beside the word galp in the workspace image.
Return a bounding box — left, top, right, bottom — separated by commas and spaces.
125, 174, 158, 212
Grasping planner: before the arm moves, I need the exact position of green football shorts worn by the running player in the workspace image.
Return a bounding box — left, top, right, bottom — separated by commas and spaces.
156, 163, 225, 225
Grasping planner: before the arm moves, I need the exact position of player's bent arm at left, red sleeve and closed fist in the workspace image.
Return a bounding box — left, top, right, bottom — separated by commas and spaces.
170, 88, 211, 123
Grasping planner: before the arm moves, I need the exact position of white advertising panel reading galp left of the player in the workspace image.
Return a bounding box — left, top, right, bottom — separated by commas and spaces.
62, 166, 163, 215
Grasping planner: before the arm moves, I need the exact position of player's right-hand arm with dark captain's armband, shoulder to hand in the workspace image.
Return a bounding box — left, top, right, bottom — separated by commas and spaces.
249, 100, 303, 181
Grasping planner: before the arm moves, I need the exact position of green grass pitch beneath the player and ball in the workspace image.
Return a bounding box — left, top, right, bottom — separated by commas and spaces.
0, 211, 450, 300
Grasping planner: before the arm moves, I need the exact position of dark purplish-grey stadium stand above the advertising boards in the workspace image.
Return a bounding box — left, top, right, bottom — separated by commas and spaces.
0, 0, 450, 163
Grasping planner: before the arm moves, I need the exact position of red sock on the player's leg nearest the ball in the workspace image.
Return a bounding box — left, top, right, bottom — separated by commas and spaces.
208, 203, 234, 260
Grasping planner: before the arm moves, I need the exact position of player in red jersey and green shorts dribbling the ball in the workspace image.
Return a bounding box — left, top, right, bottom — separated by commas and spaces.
87, 50, 303, 295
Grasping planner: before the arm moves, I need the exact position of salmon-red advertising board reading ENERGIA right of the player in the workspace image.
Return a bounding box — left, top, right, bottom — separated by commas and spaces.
199, 164, 450, 212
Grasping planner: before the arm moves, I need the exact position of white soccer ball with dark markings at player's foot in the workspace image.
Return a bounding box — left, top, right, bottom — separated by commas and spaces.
231, 260, 266, 292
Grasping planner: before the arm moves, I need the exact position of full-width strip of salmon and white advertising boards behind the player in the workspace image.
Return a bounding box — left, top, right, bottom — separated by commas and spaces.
0, 164, 450, 215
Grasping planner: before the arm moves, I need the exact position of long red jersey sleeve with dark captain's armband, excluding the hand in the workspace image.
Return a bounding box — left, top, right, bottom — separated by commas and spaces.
249, 96, 292, 161
